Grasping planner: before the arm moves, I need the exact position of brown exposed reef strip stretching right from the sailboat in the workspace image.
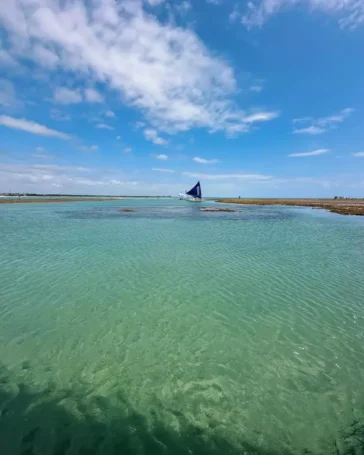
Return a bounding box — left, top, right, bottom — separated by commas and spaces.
216, 198, 364, 216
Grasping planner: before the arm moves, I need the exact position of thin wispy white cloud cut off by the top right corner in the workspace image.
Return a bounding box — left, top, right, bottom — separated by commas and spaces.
241, 0, 364, 29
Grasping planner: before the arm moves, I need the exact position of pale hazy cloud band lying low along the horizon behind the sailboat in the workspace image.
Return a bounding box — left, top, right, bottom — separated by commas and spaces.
0, 161, 358, 197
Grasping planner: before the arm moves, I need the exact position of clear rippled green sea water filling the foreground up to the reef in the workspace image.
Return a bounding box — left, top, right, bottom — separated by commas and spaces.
0, 200, 364, 455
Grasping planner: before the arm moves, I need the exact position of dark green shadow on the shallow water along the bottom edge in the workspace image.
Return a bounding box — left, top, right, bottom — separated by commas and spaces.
0, 368, 364, 455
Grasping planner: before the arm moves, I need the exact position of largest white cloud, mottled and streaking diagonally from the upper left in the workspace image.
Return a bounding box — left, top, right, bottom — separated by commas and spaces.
0, 0, 276, 135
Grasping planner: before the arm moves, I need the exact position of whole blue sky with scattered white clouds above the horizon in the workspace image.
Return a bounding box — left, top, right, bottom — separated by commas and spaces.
0, 0, 364, 197
